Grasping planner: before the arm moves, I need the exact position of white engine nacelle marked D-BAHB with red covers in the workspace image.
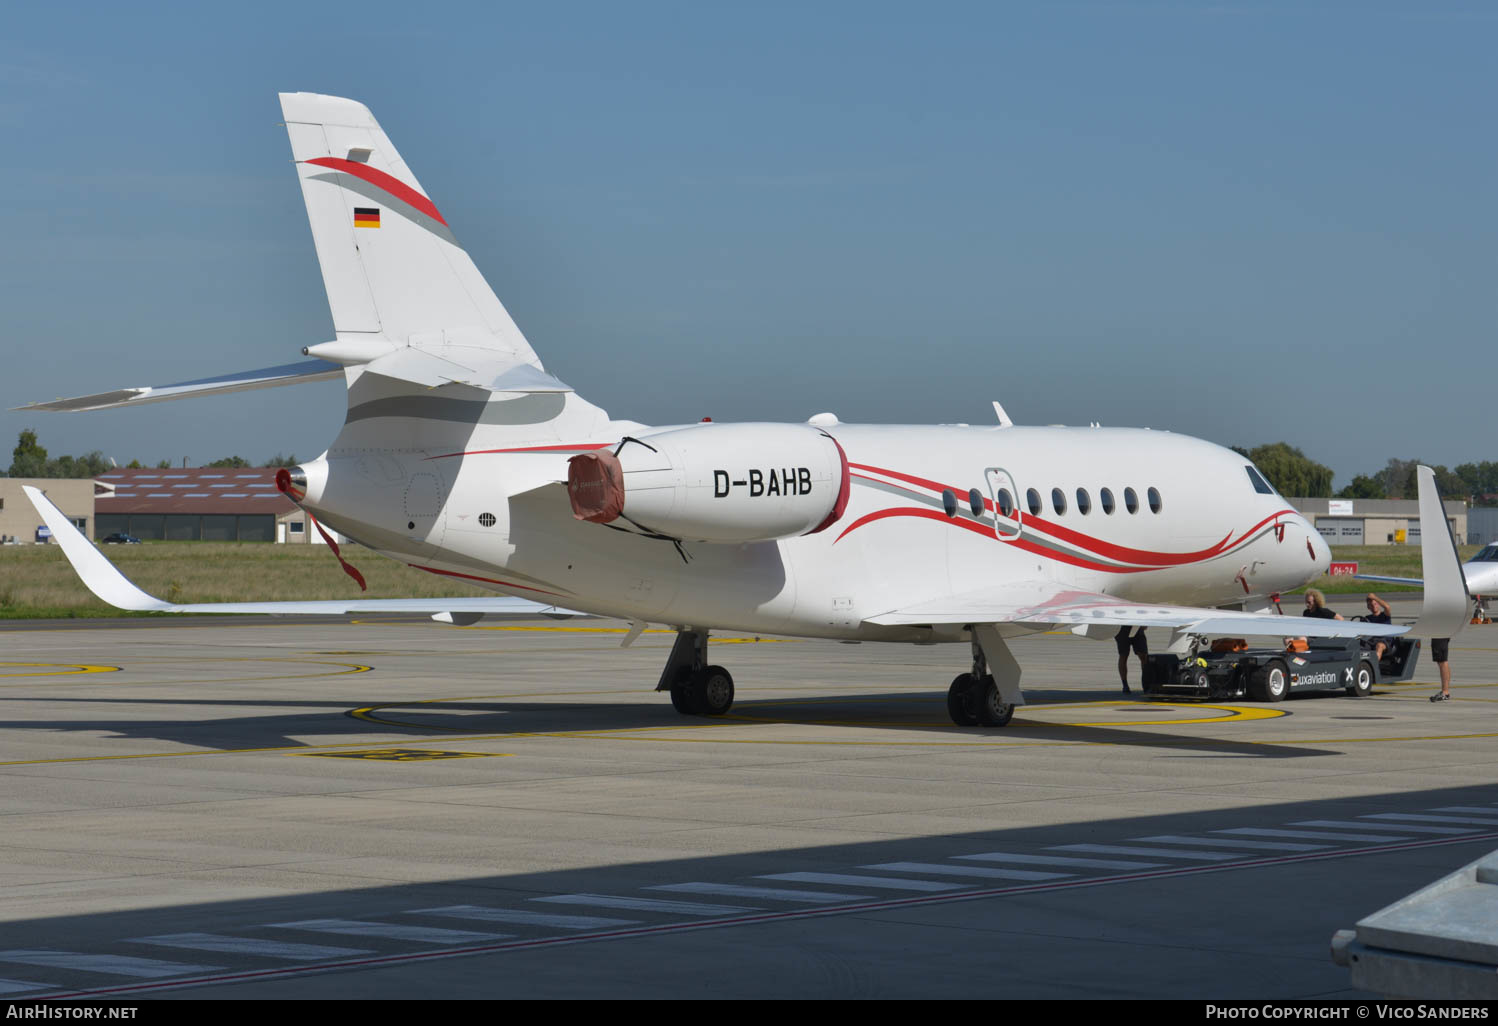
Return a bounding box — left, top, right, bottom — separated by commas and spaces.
566, 424, 848, 544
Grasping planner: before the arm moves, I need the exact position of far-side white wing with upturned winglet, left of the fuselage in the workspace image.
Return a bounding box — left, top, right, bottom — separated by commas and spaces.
22, 485, 587, 626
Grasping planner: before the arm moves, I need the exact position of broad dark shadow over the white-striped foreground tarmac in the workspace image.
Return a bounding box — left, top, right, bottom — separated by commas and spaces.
0, 783, 1498, 999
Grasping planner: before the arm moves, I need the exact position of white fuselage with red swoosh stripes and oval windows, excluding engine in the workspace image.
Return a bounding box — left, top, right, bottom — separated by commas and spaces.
303, 410, 1330, 641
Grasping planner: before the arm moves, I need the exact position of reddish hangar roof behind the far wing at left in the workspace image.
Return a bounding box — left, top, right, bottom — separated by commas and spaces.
94, 467, 295, 517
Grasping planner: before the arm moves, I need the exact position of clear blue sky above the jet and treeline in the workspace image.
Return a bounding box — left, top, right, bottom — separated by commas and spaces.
0, 0, 1498, 484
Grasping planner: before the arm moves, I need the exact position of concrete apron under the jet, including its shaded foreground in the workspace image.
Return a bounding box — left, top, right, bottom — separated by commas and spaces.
0, 607, 1498, 1001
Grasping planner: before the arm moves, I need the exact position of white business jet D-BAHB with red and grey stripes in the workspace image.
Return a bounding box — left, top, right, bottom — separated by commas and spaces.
24, 93, 1467, 726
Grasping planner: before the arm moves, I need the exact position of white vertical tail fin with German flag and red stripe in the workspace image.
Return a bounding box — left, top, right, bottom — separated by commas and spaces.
280, 93, 541, 371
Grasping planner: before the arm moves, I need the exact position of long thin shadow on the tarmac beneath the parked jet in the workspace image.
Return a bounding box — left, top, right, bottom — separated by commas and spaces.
0, 689, 1360, 759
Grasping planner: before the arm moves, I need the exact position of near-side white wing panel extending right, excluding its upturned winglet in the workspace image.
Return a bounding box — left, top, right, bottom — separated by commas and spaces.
866, 580, 1410, 638
